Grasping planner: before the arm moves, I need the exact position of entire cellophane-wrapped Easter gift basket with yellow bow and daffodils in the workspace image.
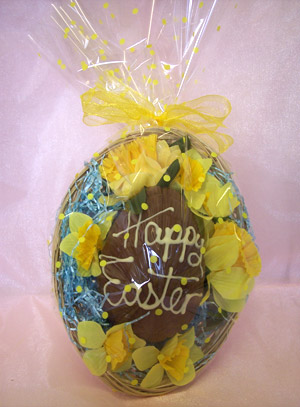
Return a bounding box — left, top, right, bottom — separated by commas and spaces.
36, 0, 261, 396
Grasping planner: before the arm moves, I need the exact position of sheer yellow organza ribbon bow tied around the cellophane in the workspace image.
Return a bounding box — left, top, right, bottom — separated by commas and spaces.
81, 77, 233, 153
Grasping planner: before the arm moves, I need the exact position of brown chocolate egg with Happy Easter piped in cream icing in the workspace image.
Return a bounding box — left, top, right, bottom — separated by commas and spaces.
97, 186, 205, 343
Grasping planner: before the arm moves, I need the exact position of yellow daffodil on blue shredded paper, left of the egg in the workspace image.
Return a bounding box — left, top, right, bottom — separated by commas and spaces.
60, 212, 116, 277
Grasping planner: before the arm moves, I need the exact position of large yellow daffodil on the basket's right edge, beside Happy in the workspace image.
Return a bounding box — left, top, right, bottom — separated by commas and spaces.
204, 222, 261, 312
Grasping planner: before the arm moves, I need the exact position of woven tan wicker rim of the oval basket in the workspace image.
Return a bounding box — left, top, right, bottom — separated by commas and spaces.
52, 128, 244, 396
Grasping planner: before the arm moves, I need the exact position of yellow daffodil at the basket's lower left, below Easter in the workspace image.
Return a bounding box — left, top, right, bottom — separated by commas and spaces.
77, 321, 146, 376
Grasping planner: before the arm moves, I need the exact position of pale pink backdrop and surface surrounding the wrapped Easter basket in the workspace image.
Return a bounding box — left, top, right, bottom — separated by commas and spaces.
0, 0, 300, 407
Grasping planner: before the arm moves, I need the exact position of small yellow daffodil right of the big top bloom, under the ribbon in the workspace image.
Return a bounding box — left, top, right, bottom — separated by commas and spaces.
176, 149, 212, 193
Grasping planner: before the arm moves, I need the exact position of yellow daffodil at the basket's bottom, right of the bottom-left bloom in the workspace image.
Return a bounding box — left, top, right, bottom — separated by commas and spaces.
132, 327, 204, 388
